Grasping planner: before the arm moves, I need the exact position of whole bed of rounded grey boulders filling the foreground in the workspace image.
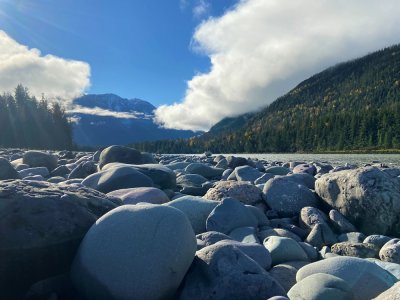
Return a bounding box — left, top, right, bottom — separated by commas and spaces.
0, 146, 400, 300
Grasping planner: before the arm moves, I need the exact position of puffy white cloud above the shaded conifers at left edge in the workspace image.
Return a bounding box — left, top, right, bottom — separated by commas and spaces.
0, 30, 90, 100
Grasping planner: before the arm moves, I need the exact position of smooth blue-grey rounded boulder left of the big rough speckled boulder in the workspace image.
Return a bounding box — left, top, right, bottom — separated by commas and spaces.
263, 177, 318, 217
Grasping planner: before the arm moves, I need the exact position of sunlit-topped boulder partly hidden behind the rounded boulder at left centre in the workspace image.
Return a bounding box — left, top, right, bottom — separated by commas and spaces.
102, 163, 176, 189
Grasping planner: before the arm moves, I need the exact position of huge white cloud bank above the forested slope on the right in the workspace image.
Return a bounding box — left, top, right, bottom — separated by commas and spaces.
156, 0, 400, 130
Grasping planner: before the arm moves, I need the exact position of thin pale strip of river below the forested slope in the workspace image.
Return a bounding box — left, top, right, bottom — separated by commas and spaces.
217, 153, 400, 167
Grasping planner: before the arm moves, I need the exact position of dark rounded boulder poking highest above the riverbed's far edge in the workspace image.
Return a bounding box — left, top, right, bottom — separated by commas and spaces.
99, 145, 142, 170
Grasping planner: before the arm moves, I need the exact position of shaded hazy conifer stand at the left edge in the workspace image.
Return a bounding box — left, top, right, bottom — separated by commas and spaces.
0, 85, 73, 150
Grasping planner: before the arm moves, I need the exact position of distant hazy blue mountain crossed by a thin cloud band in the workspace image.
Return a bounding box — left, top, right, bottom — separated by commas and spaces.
68, 94, 199, 146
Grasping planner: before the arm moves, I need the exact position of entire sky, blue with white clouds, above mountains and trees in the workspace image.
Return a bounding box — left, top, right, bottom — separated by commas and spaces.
0, 0, 400, 130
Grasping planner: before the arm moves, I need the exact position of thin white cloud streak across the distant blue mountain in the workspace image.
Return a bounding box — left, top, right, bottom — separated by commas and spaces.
67, 105, 152, 120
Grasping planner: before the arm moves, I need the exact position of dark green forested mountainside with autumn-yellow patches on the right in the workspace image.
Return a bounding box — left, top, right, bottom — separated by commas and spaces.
133, 45, 400, 153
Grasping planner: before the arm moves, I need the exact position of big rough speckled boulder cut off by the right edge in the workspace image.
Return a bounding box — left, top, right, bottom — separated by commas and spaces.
315, 167, 400, 236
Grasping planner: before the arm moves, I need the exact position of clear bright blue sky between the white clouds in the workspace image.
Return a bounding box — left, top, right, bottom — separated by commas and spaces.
0, 0, 235, 106
